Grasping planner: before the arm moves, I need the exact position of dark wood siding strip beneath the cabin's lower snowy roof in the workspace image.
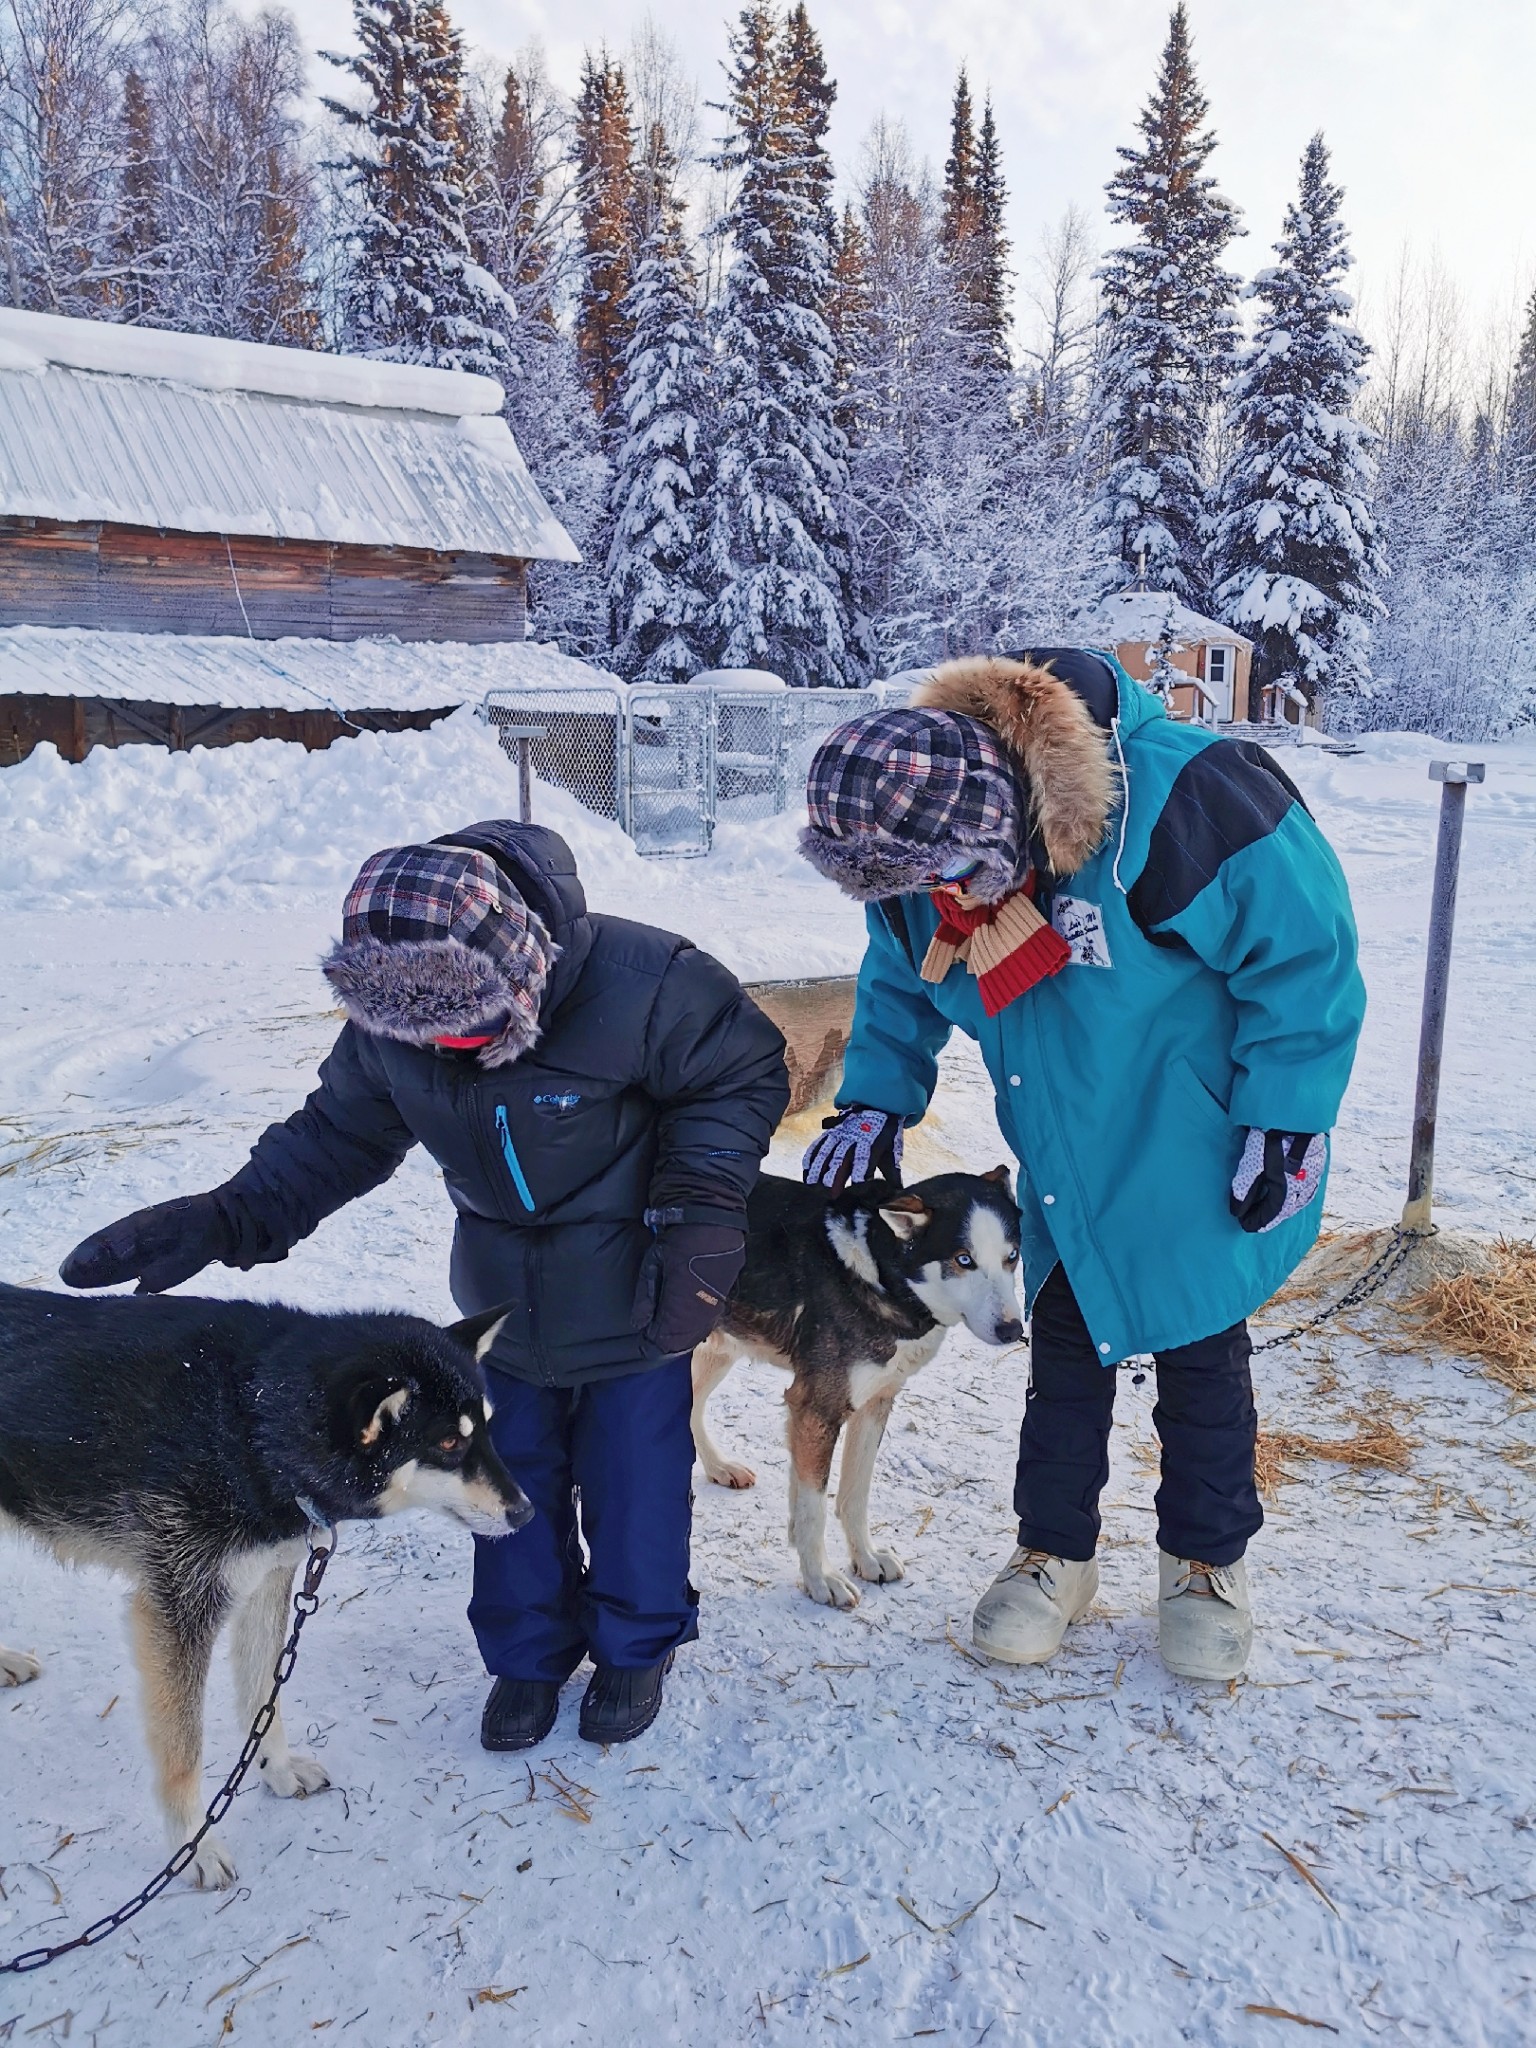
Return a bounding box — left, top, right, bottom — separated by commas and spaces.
0, 696, 453, 768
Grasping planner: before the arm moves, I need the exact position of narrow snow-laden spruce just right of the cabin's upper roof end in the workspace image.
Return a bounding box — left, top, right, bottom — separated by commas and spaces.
608, 137, 709, 682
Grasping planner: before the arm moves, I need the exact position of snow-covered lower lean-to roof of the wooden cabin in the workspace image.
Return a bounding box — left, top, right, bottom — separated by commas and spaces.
0, 627, 614, 711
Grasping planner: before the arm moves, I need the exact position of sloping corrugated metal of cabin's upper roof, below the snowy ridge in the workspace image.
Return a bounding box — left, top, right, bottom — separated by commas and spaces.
0, 322, 580, 561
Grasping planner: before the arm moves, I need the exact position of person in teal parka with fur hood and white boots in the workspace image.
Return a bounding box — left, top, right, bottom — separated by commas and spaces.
801, 649, 1364, 1679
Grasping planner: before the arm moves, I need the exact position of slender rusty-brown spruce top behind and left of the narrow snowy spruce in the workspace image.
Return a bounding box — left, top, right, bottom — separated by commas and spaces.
575, 51, 635, 414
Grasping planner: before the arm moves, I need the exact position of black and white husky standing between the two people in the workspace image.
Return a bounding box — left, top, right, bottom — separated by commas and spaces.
692, 1165, 1024, 1608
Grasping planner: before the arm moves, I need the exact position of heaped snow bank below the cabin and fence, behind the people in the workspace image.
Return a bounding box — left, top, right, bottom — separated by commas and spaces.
0, 712, 864, 979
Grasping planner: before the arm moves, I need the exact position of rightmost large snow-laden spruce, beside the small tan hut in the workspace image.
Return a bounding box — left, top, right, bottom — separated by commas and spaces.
1214, 135, 1384, 720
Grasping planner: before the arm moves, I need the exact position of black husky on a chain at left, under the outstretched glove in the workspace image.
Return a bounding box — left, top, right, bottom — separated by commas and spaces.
0, 1284, 532, 1888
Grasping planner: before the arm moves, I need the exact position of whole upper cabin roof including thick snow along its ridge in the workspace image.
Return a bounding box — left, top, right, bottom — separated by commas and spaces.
0, 309, 580, 561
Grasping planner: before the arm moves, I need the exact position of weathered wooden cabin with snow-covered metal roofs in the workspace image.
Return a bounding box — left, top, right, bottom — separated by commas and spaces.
0, 309, 580, 762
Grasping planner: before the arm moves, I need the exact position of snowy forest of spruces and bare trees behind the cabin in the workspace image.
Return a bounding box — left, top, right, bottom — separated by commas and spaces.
0, 0, 1536, 739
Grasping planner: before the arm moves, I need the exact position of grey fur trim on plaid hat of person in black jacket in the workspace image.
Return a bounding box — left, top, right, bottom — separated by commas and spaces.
322, 937, 559, 1067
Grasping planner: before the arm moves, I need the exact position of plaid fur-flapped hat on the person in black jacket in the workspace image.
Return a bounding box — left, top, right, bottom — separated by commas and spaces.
322, 842, 559, 1067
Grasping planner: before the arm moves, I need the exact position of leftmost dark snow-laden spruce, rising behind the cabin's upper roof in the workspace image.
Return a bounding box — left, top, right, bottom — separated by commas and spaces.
326, 0, 516, 375
